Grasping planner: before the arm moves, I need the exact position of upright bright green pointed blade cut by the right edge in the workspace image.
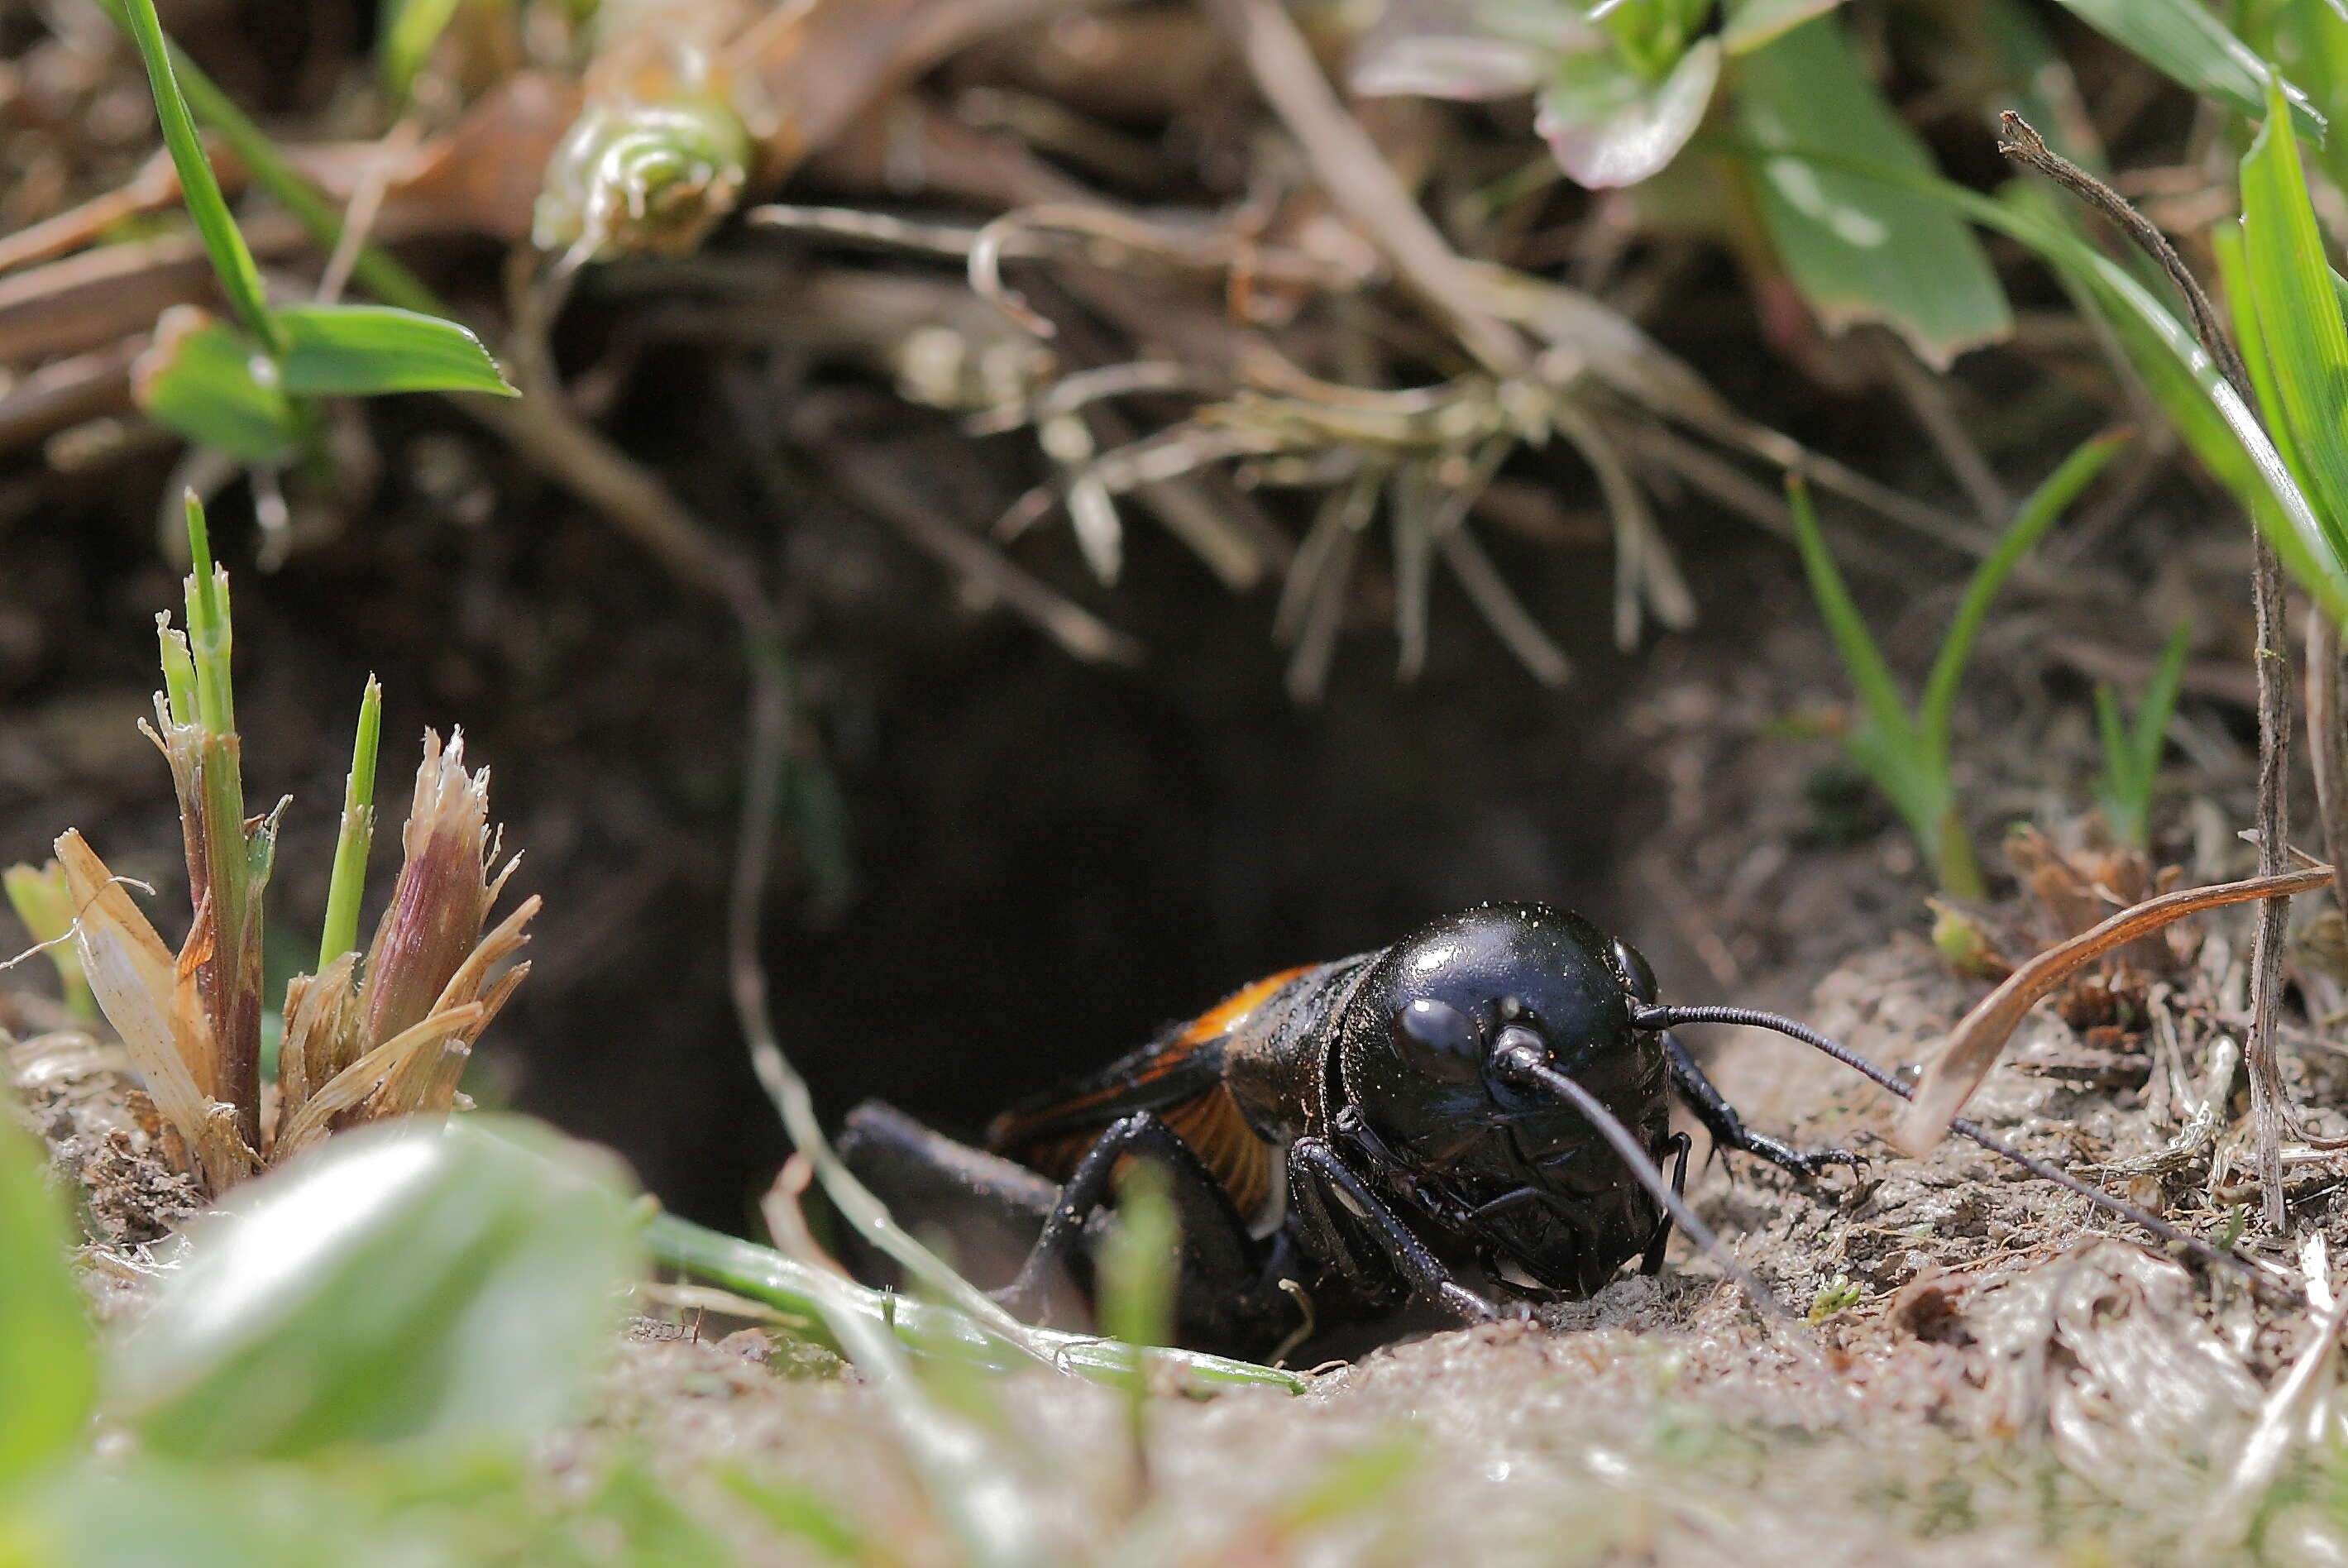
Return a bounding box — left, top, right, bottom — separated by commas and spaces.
2242, 87, 2348, 561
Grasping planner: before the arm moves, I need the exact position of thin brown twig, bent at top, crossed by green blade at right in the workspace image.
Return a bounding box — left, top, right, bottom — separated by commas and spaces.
1998, 110, 2322, 1230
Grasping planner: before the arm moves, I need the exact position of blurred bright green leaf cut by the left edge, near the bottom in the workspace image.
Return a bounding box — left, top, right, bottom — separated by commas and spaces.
0, 1112, 96, 1495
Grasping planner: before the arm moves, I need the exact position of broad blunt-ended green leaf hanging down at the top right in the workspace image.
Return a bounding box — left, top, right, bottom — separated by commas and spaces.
1735, 17, 2015, 369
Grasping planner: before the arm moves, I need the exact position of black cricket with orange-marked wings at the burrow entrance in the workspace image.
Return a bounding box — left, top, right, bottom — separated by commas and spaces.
839, 904, 1859, 1355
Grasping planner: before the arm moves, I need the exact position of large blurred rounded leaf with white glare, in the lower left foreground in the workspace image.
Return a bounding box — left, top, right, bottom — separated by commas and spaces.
112, 1115, 636, 1460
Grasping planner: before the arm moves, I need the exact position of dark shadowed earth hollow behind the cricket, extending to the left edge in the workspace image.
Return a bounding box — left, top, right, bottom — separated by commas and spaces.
0, 304, 1963, 1226
